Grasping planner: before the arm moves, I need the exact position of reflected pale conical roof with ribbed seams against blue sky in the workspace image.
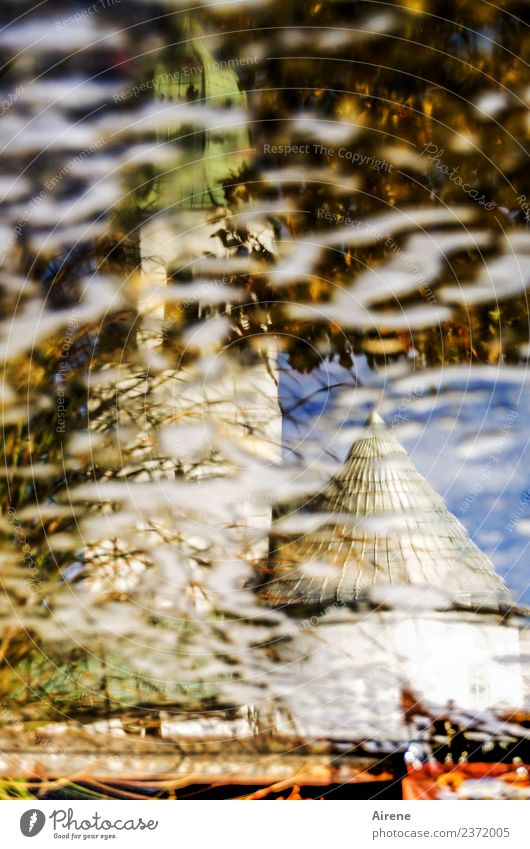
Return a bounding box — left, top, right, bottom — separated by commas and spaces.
266, 411, 511, 609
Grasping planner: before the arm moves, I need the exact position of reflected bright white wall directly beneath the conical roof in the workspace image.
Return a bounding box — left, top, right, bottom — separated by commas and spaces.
266, 611, 524, 740
